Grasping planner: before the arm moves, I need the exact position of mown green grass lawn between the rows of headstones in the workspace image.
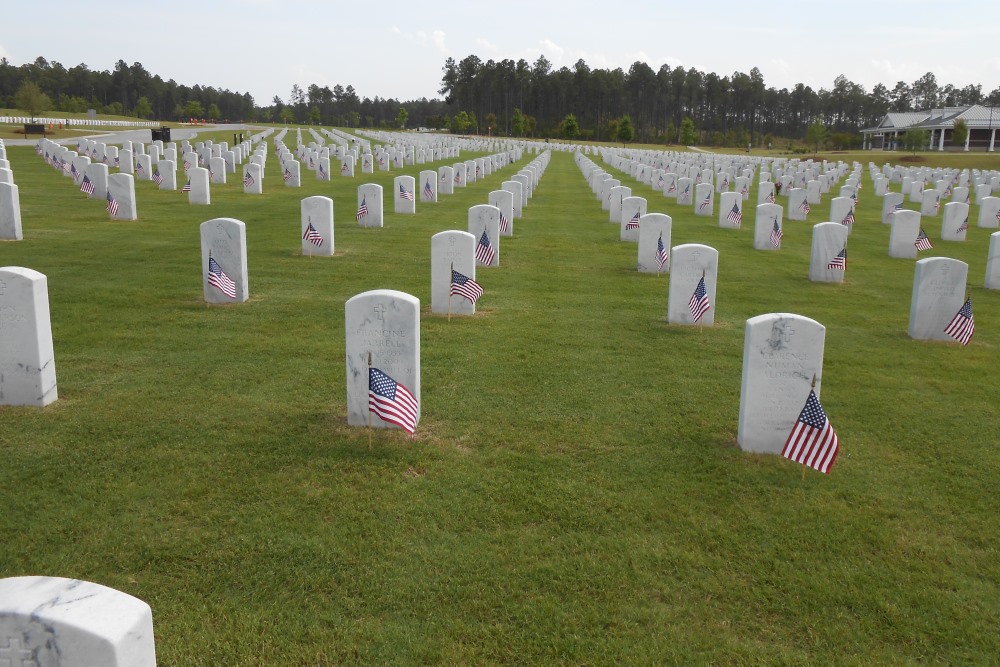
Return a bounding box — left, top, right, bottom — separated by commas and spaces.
0, 133, 1000, 666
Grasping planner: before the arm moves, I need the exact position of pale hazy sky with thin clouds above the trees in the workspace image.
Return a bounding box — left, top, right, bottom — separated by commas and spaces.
0, 0, 1000, 104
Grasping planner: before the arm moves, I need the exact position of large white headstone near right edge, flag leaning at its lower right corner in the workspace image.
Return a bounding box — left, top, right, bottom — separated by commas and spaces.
908, 257, 969, 342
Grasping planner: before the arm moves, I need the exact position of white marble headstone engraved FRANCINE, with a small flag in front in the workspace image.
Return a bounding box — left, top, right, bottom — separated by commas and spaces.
344, 289, 420, 428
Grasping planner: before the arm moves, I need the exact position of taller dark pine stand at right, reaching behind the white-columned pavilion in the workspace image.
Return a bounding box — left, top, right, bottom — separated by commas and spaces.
438, 55, 1000, 148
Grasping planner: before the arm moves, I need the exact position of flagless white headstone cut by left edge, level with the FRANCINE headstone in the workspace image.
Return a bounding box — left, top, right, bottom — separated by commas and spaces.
0, 266, 58, 408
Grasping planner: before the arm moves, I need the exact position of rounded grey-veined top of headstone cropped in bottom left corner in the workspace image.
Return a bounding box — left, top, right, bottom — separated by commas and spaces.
0, 576, 156, 667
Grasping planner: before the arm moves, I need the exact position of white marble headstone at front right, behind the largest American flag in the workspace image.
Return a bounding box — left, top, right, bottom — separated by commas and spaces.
736, 314, 828, 454
